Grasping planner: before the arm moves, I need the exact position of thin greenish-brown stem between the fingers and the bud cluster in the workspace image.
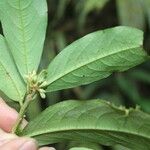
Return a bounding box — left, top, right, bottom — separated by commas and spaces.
11, 93, 35, 134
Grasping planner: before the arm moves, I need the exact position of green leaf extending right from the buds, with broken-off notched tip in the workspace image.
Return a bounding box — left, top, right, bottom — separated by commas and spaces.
47, 26, 147, 92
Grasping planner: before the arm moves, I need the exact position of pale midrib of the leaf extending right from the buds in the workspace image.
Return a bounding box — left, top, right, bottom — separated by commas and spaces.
48, 46, 140, 86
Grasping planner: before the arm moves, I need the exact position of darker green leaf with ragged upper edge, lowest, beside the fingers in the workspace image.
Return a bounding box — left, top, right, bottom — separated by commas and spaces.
22, 100, 150, 150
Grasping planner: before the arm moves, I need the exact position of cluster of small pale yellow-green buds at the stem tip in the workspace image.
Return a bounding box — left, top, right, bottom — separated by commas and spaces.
25, 70, 47, 98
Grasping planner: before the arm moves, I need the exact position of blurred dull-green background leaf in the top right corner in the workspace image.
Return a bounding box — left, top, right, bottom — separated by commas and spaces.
117, 0, 145, 29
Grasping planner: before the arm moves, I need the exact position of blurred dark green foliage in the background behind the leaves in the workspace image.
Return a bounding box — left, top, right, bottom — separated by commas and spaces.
1, 0, 150, 150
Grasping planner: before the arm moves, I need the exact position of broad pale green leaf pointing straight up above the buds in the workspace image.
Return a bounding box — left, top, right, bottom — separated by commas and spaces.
0, 0, 47, 77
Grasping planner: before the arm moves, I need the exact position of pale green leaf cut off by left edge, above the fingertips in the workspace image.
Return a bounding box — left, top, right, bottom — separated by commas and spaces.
0, 35, 26, 102
